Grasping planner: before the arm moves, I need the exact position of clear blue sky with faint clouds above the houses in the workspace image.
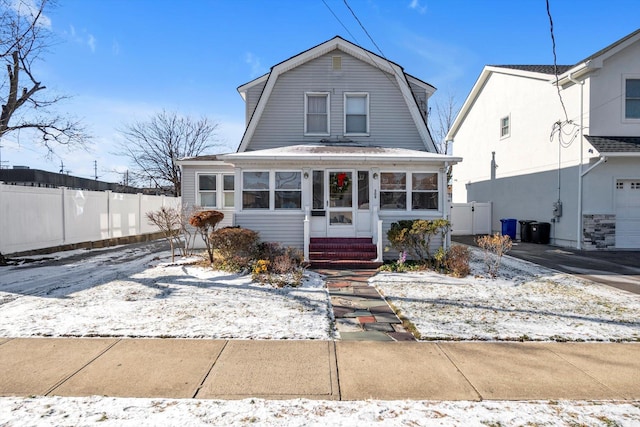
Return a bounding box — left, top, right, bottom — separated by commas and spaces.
2, 0, 640, 182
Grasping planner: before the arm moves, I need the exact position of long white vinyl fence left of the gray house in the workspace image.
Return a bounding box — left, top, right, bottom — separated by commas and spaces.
0, 184, 181, 254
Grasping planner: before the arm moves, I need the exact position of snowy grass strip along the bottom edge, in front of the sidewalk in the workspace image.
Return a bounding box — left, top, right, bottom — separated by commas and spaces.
0, 396, 640, 426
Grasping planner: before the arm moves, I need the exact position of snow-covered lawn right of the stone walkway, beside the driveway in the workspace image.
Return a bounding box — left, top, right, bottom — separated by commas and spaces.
370, 248, 640, 341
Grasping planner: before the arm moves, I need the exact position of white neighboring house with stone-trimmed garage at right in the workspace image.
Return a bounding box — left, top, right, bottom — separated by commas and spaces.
447, 30, 640, 249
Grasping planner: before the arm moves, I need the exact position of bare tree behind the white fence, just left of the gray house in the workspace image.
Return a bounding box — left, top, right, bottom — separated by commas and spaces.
118, 111, 218, 196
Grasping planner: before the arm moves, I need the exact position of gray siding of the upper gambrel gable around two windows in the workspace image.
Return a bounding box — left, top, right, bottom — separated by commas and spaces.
247, 50, 426, 151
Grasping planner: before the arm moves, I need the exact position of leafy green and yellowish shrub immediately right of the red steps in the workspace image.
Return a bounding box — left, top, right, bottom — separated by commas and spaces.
387, 219, 451, 263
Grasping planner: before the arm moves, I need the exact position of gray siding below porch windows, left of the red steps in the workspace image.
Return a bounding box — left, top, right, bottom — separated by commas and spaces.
235, 211, 304, 249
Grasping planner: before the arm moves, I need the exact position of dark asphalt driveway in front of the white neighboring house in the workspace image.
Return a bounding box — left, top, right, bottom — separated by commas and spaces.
451, 236, 640, 294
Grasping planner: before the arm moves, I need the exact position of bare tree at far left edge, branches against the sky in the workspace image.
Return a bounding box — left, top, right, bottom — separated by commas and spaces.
0, 0, 88, 154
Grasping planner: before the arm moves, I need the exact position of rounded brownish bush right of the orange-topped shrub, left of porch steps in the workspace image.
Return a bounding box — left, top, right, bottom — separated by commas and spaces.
209, 227, 258, 271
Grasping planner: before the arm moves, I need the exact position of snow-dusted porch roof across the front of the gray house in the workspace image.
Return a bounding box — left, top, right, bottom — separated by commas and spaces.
218, 143, 462, 166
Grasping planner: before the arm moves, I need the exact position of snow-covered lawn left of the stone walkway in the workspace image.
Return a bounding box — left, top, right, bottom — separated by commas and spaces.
0, 247, 334, 339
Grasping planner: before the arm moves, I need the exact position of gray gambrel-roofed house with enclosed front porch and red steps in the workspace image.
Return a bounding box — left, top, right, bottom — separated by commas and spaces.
181, 37, 461, 265
